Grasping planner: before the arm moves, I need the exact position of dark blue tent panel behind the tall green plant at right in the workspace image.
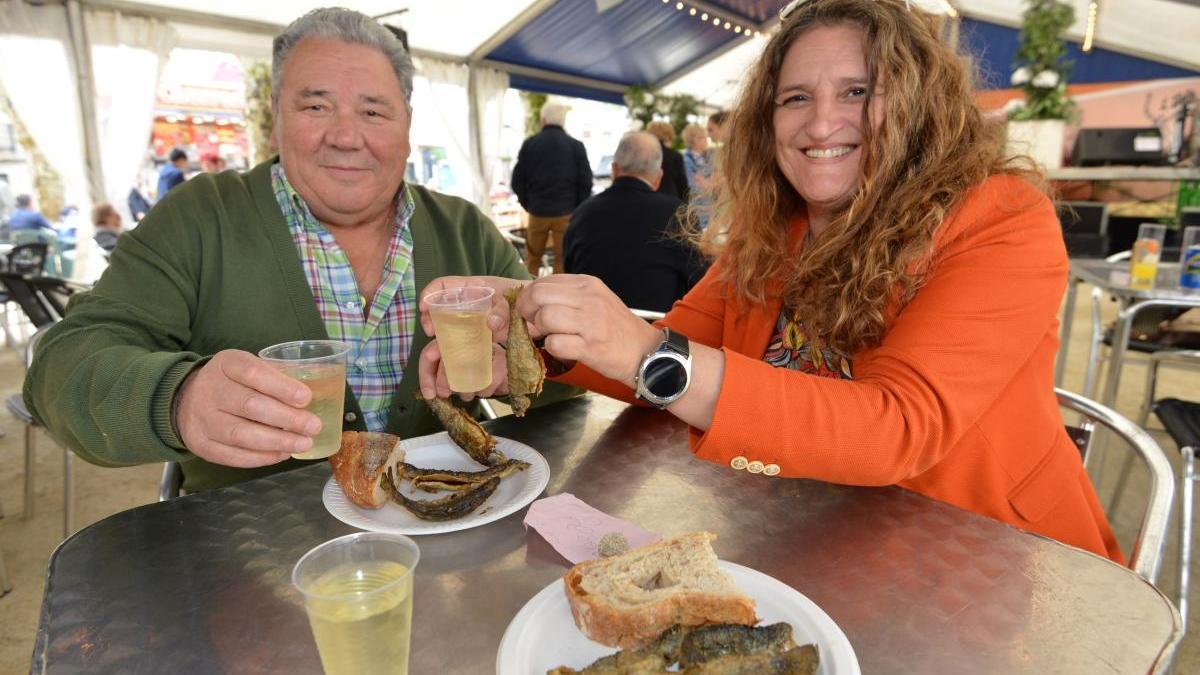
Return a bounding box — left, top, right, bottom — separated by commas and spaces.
960, 19, 1200, 89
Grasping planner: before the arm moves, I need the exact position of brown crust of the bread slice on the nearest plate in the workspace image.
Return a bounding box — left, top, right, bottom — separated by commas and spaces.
563, 533, 758, 649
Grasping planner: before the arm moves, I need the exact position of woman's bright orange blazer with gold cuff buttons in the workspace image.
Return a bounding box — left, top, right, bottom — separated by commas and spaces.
559, 175, 1123, 562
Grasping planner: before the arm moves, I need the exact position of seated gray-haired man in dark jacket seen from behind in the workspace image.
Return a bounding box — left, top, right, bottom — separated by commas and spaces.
565, 132, 706, 312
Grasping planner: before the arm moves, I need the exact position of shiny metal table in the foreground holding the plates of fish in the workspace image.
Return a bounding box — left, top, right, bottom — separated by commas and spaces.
32, 395, 1181, 675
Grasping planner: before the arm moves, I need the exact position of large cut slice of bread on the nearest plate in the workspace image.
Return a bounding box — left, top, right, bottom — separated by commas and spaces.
563, 532, 758, 649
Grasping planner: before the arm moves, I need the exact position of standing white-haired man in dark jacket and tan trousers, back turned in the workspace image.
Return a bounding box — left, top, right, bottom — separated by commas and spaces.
512, 103, 592, 276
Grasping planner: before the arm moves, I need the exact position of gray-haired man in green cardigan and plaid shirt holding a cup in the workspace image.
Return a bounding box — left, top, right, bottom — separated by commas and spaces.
24, 8, 540, 490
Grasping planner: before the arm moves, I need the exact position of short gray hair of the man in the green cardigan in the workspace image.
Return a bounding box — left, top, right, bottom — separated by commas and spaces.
271, 7, 415, 107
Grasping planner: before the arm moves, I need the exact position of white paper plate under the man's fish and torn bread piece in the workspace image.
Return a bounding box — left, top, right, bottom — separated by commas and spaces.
322, 431, 550, 534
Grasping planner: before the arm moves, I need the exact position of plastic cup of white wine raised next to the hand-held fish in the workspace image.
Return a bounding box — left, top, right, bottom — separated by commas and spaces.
425, 286, 496, 393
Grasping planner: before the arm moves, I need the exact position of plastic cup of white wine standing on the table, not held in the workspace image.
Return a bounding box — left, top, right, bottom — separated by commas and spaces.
292, 532, 421, 675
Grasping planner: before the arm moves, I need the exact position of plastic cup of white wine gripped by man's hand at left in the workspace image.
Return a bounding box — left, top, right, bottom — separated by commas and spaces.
258, 340, 350, 459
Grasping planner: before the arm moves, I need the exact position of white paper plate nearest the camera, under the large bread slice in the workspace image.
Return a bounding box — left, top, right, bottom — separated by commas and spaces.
496, 560, 862, 675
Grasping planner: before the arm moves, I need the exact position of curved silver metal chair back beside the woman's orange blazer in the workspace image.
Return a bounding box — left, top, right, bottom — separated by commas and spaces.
1055, 388, 1175, 584
